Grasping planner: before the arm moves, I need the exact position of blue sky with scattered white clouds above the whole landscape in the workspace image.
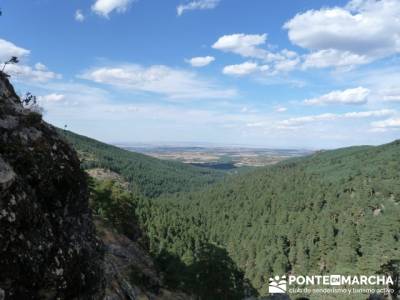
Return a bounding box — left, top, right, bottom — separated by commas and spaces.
0, 0, 400, 149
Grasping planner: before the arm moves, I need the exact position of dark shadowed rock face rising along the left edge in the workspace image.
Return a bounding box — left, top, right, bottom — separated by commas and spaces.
0, 72, 104, 299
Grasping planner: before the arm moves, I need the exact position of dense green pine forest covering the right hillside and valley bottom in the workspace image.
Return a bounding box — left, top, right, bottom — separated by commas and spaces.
62, 131, 400, 299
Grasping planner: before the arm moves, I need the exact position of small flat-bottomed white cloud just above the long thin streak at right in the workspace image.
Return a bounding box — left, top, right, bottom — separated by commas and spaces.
304, 87, 370, 105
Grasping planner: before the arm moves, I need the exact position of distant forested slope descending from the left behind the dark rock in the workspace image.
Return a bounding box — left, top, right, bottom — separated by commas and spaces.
59, 130, 224, 198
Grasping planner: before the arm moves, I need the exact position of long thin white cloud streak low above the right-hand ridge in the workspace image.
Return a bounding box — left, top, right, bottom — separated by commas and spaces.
278, 109, 396, 129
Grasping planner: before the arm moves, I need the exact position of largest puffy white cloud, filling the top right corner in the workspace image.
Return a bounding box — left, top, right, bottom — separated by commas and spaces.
284, 0, 400, 68
